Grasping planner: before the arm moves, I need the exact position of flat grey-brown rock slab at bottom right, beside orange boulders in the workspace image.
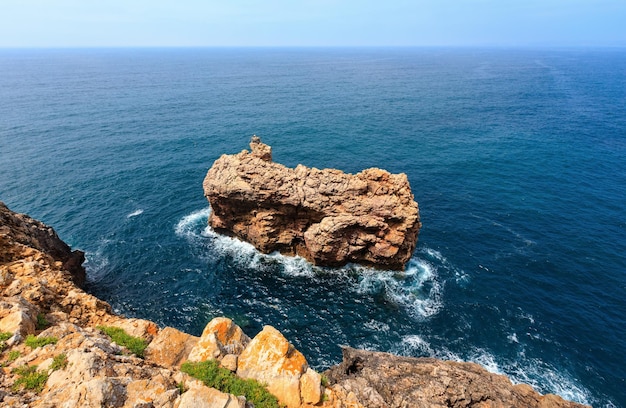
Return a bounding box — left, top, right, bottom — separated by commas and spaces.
325, 347, 584, 408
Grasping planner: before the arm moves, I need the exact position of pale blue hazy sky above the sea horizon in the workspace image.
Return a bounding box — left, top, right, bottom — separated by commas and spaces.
0, 0, 626, 47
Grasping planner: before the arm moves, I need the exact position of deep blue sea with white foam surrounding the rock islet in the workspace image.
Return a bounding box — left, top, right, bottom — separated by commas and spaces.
0, 48, 626, 407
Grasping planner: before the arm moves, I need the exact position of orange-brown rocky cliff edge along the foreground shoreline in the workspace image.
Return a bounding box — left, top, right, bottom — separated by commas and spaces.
0, 203, 582, 408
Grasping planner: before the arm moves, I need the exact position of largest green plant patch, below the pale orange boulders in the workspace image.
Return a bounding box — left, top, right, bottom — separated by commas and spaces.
180, 360, 280, 408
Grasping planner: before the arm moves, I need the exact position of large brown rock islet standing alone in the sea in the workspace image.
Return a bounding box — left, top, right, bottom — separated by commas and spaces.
204, 136, 421, 269
